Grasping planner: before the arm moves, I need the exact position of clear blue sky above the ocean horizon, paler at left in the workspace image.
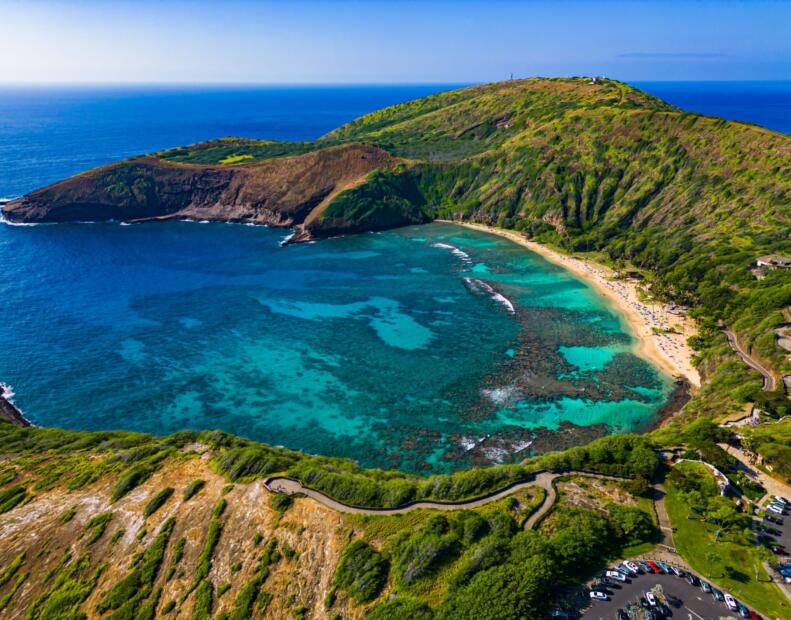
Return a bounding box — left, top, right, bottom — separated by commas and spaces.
0, 0, 791, 83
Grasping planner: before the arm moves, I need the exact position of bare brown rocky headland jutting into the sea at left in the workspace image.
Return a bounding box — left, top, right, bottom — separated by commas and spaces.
3, 144, 396, 236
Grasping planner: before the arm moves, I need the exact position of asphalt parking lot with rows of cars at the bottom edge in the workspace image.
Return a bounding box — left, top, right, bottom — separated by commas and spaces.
582, 574, 756, 620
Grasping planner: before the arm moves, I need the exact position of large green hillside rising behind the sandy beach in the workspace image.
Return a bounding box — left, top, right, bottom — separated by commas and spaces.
153, 78, 791, 415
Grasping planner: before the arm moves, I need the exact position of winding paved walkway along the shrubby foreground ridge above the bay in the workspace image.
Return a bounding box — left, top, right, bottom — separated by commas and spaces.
264, 471, 629, 529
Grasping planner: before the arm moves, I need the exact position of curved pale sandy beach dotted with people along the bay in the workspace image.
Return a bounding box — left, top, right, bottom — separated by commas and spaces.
448, 221, 700, 389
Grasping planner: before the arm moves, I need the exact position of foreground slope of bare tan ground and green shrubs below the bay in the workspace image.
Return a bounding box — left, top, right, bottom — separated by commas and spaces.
0, 422, 656, 618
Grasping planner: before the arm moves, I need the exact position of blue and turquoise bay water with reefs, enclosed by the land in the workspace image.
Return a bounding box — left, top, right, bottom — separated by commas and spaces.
0, 222, 670, 471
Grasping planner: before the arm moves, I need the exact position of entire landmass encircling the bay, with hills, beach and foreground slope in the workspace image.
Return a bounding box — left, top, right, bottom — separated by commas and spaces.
0, 78, 791, 620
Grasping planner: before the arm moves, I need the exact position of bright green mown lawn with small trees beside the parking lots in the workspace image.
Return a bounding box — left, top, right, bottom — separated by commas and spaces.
665, 463, 791, 618
